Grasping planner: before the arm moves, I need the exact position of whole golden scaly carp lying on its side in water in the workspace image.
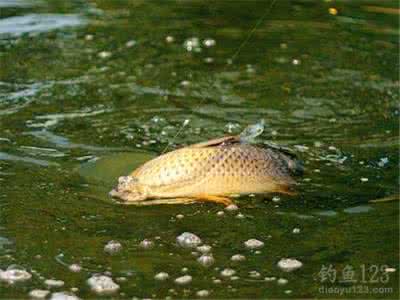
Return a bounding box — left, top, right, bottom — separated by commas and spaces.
110, 124, 301, 205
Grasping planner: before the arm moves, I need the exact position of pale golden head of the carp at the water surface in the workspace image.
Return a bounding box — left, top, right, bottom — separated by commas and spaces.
110, 176, 149, 202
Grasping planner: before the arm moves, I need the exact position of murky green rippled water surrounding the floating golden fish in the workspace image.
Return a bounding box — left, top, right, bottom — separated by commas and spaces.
0, 0, 399, 299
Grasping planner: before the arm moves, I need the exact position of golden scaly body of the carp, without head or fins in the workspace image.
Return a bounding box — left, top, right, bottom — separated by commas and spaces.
131, 144, 294, 198
